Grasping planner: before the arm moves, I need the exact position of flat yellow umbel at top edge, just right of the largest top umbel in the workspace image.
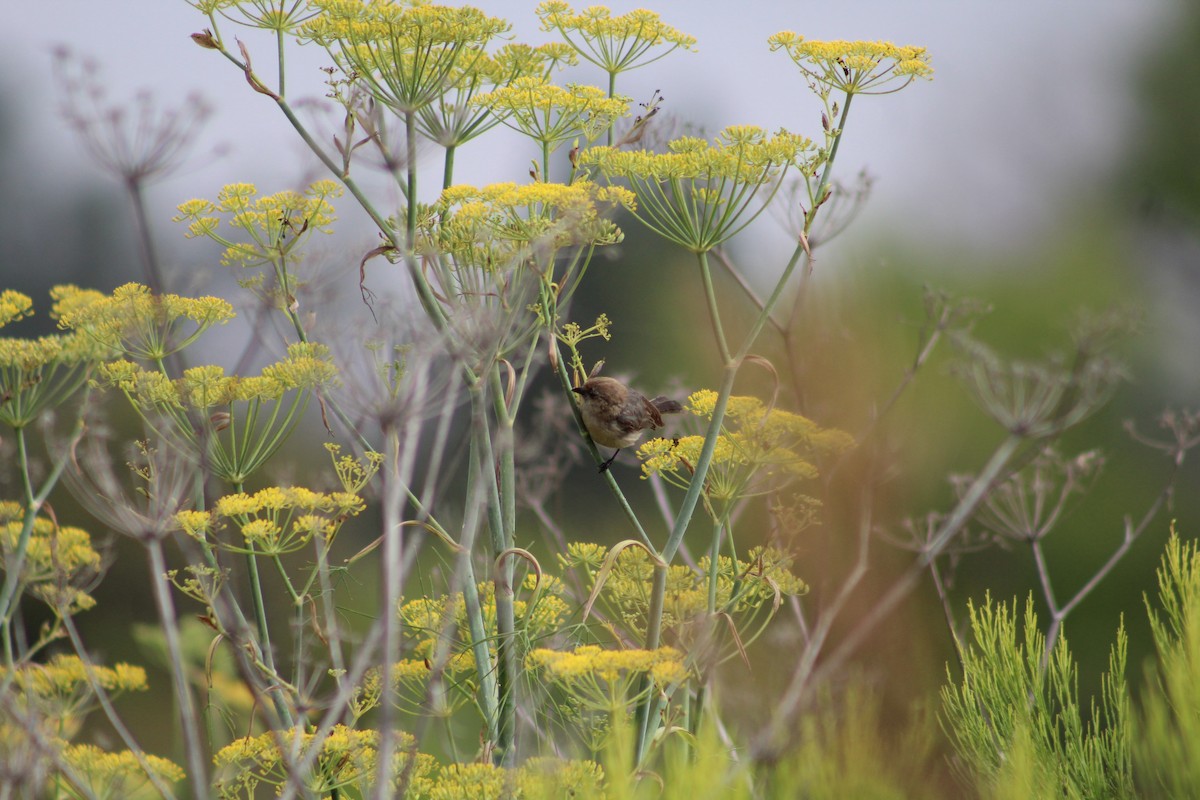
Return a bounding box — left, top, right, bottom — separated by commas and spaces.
538, 0, 696, 74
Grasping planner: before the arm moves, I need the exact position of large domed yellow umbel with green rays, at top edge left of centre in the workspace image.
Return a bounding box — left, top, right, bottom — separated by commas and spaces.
302, 0, 510, 114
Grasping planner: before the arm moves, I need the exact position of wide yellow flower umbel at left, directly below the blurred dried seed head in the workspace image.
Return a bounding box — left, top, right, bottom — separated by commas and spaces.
59, 283, 234, 361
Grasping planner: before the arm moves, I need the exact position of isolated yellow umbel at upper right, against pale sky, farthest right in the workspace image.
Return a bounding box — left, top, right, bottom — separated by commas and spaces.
767, 31, 934, 95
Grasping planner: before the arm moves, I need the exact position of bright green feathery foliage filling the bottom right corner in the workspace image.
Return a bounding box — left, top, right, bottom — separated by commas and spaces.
942, 527, 1200, 798
